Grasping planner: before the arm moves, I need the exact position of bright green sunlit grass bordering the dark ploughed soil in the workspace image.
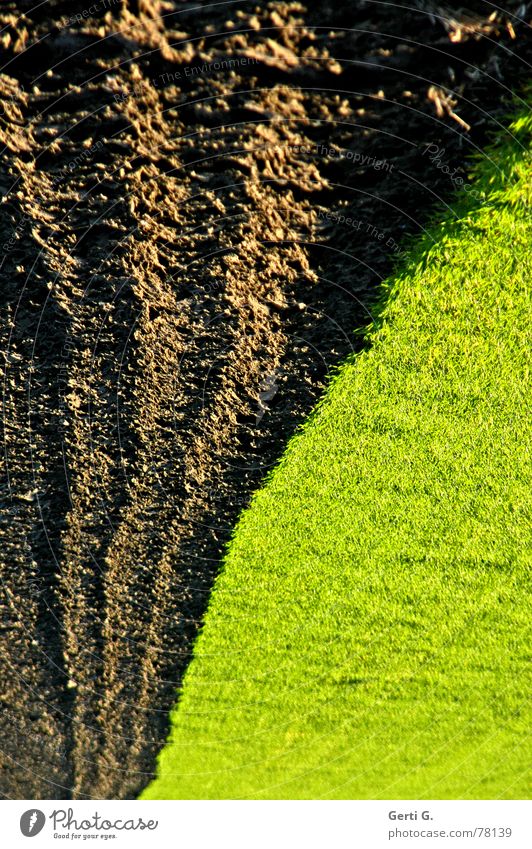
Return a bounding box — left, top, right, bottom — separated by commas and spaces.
141, 102, 532, 799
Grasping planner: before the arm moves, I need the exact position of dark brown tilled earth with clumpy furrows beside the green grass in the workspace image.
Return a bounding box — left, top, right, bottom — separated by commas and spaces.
0, 0, 532, 799
